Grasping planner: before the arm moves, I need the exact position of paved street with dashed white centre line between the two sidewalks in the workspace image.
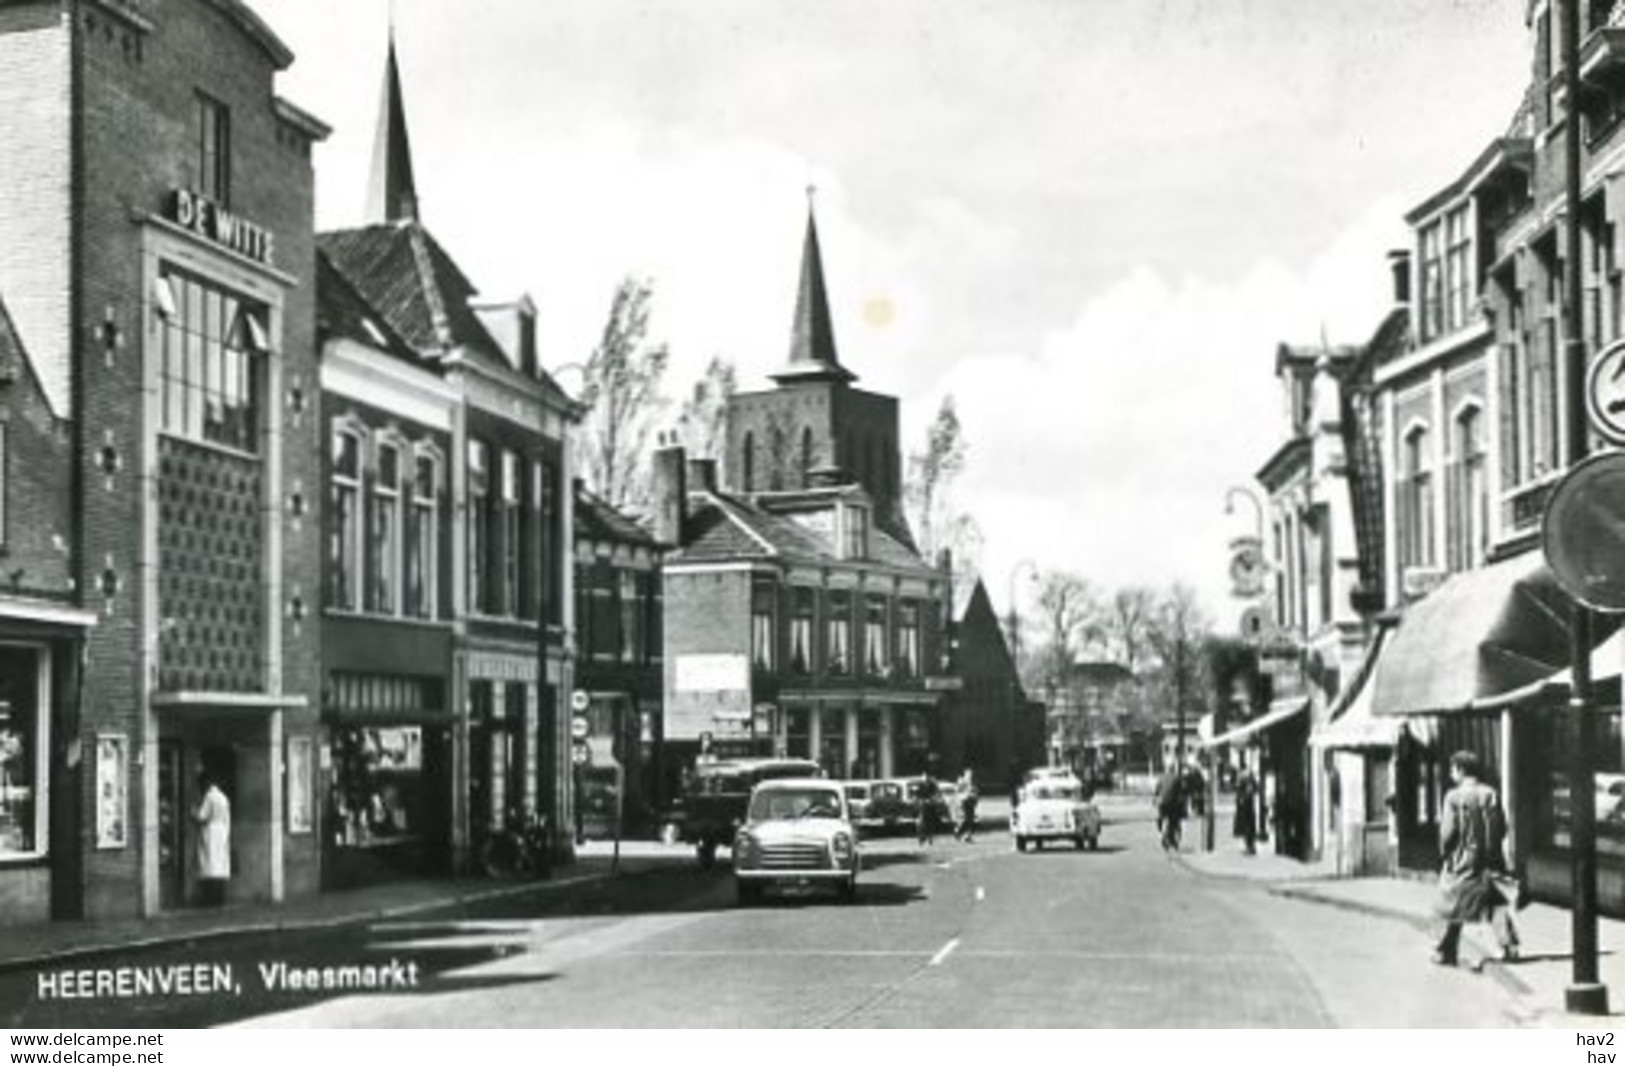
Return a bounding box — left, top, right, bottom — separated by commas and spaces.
0, 801, 1510, 1027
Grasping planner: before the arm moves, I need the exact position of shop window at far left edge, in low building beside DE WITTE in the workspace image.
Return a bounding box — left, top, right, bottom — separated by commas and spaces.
0, 647, 49, 858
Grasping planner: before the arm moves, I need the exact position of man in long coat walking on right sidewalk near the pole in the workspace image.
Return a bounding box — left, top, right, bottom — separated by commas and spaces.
1433, 751, 1518, 965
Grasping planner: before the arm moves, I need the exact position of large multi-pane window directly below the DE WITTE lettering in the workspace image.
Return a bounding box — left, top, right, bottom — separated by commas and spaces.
159, 267, 268, 453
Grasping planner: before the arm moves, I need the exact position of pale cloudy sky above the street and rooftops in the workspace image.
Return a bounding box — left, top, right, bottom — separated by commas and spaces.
255, 0, 1529, 627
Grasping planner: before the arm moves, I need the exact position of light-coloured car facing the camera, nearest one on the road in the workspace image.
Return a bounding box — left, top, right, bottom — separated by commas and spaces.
733, 777, 860, 905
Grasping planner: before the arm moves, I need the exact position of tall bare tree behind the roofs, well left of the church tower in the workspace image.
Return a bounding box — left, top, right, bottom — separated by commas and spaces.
577, 278, 670, 510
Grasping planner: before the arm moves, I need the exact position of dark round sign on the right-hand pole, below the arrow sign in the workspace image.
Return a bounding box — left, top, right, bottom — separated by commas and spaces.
1542, 452, 1625, 611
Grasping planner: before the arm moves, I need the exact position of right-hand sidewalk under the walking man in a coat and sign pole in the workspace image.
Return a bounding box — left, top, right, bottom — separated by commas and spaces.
1180, 840, 1625, 1027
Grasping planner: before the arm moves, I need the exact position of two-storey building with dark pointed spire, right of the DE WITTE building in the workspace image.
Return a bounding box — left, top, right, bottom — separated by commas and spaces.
319, 35, 574, 878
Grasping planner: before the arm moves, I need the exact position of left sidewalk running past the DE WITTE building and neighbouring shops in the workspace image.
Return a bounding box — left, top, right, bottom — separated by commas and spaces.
0, 842, 694, 972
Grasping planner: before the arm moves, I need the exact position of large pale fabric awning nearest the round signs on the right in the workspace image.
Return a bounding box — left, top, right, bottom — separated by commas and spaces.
1372, 551, 1606, 715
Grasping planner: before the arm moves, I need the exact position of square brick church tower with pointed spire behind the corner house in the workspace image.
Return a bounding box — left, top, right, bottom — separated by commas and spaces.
726, 202, 913, 543
